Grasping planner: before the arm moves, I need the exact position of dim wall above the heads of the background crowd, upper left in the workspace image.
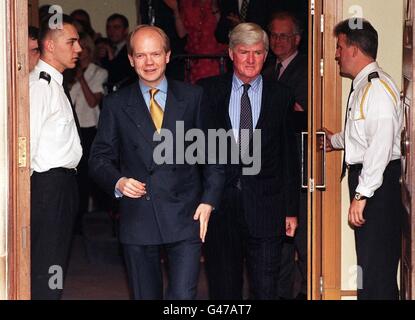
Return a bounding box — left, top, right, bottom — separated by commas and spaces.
39, 0, 137, 37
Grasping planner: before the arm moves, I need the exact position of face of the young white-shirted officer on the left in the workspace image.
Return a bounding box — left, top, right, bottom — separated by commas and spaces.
46, 23, 82, 72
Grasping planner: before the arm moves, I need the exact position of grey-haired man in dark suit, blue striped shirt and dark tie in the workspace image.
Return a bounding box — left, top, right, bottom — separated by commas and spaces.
200, 23, 300, 299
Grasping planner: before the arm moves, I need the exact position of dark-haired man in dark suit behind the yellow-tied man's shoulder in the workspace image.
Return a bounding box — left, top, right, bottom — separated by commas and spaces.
100, 13, 136, 92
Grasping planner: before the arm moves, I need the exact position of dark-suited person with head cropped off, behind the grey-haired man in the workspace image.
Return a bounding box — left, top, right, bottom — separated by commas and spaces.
215, 0, 270, 44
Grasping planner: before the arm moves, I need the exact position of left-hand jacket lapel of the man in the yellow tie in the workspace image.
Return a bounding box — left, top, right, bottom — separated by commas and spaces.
122, 82, 156, 146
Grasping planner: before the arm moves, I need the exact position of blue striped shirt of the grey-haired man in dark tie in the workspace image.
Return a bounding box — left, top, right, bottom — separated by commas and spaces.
229, 74, 262, 141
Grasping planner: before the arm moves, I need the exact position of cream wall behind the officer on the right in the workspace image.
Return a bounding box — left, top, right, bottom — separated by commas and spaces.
341, 0, 404, 298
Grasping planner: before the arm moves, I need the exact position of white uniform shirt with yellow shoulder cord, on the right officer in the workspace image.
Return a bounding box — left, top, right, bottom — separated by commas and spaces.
331, 62, 403, 197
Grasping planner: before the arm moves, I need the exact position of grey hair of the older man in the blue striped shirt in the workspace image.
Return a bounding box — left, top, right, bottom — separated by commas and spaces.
229, 22, 269, 51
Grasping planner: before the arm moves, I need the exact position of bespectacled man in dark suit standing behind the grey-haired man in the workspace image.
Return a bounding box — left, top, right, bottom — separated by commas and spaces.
263, 12, 308, 299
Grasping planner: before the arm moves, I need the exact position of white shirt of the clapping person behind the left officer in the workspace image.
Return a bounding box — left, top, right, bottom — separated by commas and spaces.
70, 63, 108, 128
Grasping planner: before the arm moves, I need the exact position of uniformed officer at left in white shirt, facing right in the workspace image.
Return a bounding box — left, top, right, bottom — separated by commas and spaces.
29, 15, 82, 299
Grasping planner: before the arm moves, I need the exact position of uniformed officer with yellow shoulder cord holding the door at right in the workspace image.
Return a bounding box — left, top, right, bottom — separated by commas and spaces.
324, 19, 404, 299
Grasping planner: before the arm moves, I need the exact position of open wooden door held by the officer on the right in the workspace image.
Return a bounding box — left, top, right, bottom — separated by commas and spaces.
308, 0, 342, 300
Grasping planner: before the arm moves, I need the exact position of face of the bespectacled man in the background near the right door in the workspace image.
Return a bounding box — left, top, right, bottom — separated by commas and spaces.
269, 19, 301, 61
